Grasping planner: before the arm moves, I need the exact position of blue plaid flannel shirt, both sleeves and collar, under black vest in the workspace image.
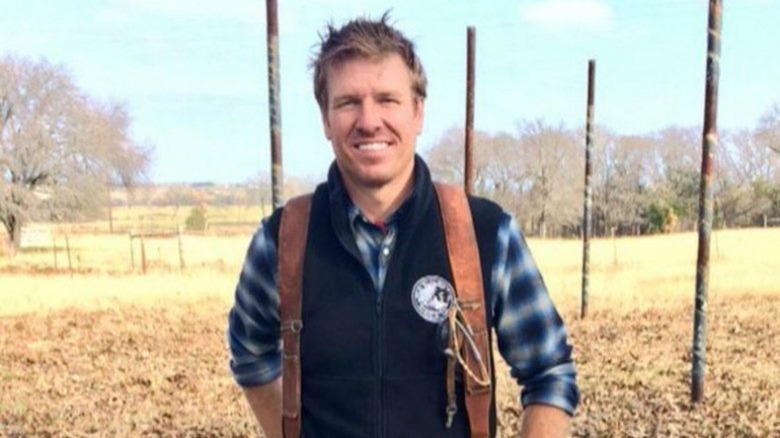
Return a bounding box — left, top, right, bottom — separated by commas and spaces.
227, 205, 580, 414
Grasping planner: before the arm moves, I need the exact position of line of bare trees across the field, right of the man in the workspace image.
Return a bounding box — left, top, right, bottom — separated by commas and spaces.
425, 109, 780, 240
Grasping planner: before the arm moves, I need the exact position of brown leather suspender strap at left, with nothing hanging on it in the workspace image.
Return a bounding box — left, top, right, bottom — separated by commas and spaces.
277, 195, 311, 438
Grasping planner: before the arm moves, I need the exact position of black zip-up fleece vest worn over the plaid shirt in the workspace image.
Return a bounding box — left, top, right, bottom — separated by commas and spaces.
270, 160, 502, 438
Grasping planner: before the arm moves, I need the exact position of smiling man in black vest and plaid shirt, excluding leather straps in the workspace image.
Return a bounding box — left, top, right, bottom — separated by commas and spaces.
228, 14, 579, 437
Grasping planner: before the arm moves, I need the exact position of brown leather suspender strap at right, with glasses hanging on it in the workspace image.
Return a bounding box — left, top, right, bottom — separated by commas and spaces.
435, 183, 492, 438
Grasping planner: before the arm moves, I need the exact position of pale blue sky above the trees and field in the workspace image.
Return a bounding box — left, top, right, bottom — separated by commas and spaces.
0, 0, 780, 183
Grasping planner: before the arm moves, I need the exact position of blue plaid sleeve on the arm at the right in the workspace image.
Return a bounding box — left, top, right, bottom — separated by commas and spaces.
491, 214, 580, 415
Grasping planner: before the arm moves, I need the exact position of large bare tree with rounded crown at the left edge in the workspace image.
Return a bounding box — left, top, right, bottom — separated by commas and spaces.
0, 57, 150, 250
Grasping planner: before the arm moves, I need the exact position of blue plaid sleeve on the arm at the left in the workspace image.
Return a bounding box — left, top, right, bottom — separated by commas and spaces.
227, 220, 281, 387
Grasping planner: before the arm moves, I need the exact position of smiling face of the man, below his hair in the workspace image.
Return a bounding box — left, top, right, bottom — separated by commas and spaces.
322, 54, 423, 191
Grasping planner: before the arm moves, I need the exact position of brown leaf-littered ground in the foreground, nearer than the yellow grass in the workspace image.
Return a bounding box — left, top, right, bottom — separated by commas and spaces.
0, 296, 780, 437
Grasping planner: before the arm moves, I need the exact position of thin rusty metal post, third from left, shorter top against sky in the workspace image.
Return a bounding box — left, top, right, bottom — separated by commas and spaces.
580, 59, 596, 318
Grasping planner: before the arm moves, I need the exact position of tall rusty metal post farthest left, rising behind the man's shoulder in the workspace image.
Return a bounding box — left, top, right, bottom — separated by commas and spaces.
265, 0, 284, 208
